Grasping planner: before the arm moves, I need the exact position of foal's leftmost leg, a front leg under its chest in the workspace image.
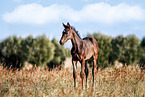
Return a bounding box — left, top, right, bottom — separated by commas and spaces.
72, 60, 77, 88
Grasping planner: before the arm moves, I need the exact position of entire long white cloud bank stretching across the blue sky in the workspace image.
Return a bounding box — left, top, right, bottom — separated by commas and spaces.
3, 3, 145, 24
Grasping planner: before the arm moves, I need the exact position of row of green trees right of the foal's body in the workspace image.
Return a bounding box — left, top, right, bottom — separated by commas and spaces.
88, 33, 145, 68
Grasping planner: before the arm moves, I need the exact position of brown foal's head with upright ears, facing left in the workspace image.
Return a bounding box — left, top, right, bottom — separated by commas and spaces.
59, 23, 73, 45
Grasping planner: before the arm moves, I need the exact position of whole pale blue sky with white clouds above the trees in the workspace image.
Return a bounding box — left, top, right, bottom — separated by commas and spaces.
0, 0, 145, 46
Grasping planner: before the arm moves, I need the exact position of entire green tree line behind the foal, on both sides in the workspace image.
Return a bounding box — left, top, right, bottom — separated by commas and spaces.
0, 33, 145, 68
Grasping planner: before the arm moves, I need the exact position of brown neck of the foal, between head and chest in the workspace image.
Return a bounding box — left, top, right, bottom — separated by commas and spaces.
71, 32, 82, 50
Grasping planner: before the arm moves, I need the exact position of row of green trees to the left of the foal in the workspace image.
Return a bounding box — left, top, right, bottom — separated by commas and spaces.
0, 35, 70, 68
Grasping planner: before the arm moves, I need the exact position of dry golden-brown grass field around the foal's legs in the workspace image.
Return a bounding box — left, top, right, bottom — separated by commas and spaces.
0, 66, 145, 97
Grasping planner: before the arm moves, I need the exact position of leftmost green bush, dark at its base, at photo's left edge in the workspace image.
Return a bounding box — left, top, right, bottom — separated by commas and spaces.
0, 36, 25, 68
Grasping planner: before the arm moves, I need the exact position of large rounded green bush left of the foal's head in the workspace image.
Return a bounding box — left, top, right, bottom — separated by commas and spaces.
28, 35, 55, 66
